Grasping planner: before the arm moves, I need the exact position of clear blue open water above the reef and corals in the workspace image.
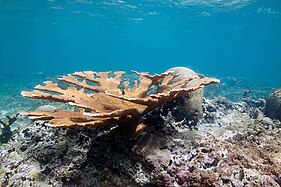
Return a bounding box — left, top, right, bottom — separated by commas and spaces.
0, 0, 281, 86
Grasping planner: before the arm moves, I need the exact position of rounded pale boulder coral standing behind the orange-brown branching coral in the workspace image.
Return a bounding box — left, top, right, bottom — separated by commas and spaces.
165, 67, 204, 125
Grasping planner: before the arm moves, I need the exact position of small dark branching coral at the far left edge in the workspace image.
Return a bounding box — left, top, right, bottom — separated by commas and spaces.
0, 114, 19, 143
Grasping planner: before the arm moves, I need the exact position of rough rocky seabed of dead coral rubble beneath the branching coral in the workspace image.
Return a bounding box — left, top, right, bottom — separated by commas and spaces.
0, 97, 281, 187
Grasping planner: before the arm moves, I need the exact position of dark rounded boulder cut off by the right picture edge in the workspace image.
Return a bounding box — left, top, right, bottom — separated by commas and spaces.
265, 89, 281, 120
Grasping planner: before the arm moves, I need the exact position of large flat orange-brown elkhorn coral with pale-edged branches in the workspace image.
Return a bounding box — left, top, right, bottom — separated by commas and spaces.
21, 71, 219, 127
